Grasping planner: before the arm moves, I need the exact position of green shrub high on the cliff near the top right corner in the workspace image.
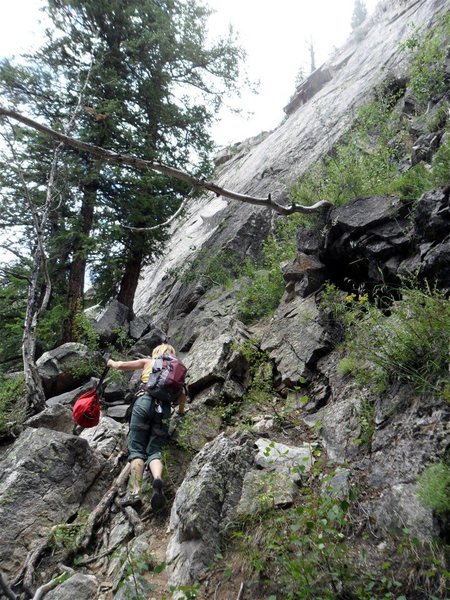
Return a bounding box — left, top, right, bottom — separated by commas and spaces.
401, 14, 450, 107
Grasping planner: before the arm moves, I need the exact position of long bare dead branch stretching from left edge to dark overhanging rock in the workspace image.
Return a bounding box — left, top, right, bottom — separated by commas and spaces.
0, 106, 331, 215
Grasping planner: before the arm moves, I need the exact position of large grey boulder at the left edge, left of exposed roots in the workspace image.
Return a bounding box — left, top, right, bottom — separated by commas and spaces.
0, 428, 104, 575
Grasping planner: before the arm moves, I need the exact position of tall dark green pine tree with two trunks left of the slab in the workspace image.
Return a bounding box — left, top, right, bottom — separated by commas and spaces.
1, 0, 243, 339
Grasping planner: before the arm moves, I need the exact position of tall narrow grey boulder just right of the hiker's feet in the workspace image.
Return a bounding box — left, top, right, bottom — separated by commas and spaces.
166, 433, 255, 587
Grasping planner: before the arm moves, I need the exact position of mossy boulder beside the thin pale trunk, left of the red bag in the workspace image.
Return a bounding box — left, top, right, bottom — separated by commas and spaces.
36, 342, 96, 403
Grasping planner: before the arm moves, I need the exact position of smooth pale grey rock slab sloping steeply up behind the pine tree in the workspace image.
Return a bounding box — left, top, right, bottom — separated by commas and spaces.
134, 0, 447, 323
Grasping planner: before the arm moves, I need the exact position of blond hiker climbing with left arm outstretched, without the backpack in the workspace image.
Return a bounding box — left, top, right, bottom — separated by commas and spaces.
107, 344, 186, 510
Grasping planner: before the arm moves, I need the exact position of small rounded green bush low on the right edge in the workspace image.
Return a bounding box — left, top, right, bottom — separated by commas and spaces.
418, 461, 450, 515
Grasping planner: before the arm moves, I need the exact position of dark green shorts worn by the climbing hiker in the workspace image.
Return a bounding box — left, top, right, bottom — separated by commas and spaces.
128, 394, 170, 463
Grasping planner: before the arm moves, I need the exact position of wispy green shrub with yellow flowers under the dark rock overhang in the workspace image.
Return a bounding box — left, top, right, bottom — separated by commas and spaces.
328, 285, 450, 394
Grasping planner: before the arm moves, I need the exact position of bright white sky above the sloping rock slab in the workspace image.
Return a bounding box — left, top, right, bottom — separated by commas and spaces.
0, 0, 377, 147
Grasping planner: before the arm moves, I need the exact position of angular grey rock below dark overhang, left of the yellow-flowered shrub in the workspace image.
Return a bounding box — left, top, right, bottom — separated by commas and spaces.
261, 297, 329, 387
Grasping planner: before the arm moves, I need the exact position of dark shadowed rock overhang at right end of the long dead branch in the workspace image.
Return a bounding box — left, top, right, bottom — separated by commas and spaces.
320, 187, 450, 289
